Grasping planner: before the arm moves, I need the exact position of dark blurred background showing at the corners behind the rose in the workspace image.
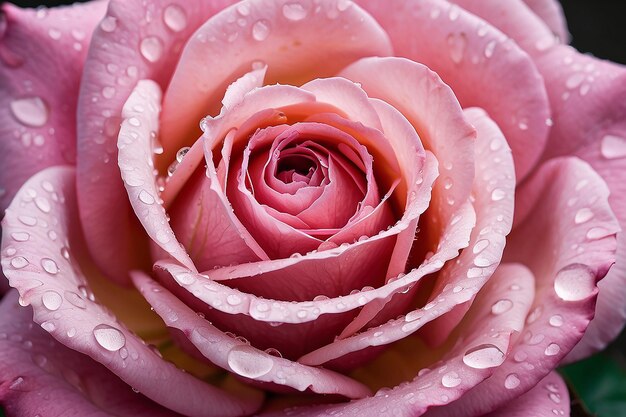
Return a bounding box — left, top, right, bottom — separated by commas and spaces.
0, 0, 626, 417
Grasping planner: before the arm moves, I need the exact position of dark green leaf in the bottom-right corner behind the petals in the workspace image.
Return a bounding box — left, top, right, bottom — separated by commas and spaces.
560, 352, 626, 417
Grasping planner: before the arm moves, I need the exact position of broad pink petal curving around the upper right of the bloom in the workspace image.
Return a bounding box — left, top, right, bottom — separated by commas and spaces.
359, 0, 550, 181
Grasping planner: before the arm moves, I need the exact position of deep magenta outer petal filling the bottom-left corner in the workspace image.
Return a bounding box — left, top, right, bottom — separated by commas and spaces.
0, 292, 183, 417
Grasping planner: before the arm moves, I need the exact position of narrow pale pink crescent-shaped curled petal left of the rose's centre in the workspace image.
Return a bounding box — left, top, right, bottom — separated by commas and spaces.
117, 80, 195, 269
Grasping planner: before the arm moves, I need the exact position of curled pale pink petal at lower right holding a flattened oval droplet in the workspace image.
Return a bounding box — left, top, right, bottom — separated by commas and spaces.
262, 264, 534, 417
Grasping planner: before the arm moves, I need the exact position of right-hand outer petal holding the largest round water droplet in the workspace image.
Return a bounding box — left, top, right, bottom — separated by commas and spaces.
432, 158, 619, 417
